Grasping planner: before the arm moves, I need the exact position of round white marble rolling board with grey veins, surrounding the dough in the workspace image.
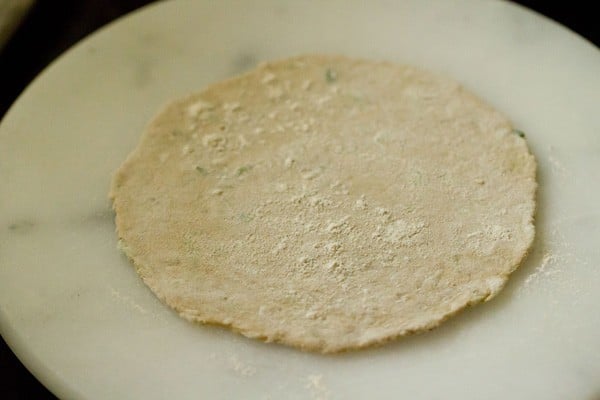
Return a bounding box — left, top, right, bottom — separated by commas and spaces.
0, 0, 600, 399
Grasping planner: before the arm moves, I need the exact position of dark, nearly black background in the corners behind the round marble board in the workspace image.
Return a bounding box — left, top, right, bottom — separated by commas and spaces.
0, 0, 600, 400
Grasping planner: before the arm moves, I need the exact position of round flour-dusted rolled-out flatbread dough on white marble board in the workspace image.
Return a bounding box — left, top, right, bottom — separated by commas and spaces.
110, 56, 536, 352
